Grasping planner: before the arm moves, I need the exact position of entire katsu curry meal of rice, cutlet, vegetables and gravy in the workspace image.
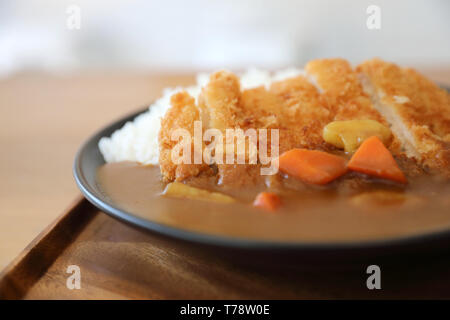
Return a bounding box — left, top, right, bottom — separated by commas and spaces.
98, 58, 450, 243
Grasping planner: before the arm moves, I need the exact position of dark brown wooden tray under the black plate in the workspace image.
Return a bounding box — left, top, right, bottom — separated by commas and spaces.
0, 198, 450, 299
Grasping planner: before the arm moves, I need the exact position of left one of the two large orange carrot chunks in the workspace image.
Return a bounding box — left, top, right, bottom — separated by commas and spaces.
279, 149, 347, 185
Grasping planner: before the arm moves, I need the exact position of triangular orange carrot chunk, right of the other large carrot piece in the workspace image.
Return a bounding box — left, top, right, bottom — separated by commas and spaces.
348, 136, 407, 183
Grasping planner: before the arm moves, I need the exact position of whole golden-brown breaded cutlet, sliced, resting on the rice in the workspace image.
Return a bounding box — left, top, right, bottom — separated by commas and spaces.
159, 59, 450, 184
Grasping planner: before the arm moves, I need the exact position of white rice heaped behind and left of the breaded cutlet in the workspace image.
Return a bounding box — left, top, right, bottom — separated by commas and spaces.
98, 68, 303, 164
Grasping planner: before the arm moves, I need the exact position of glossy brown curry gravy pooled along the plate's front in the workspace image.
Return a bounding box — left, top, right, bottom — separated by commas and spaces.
98, 162, 450, 242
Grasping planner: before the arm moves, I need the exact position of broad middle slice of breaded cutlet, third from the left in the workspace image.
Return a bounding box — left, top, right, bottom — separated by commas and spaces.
241, 76, 331, 153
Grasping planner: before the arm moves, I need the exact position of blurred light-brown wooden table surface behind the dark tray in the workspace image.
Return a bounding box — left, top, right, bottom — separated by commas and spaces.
0, 67, 450, 269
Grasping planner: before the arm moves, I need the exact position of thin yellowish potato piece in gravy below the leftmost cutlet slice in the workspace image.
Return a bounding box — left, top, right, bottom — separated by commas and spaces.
163, 182, 235, 203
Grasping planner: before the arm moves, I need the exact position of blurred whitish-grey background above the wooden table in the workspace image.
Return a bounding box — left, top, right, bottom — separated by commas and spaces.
0, 0, 450, 75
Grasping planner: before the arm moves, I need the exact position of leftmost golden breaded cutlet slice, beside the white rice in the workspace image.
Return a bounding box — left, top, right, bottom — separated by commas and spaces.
158, 91, 209, 181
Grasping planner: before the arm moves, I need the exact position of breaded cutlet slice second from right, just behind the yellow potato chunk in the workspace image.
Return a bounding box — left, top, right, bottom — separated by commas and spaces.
305, 58, 401, 154
